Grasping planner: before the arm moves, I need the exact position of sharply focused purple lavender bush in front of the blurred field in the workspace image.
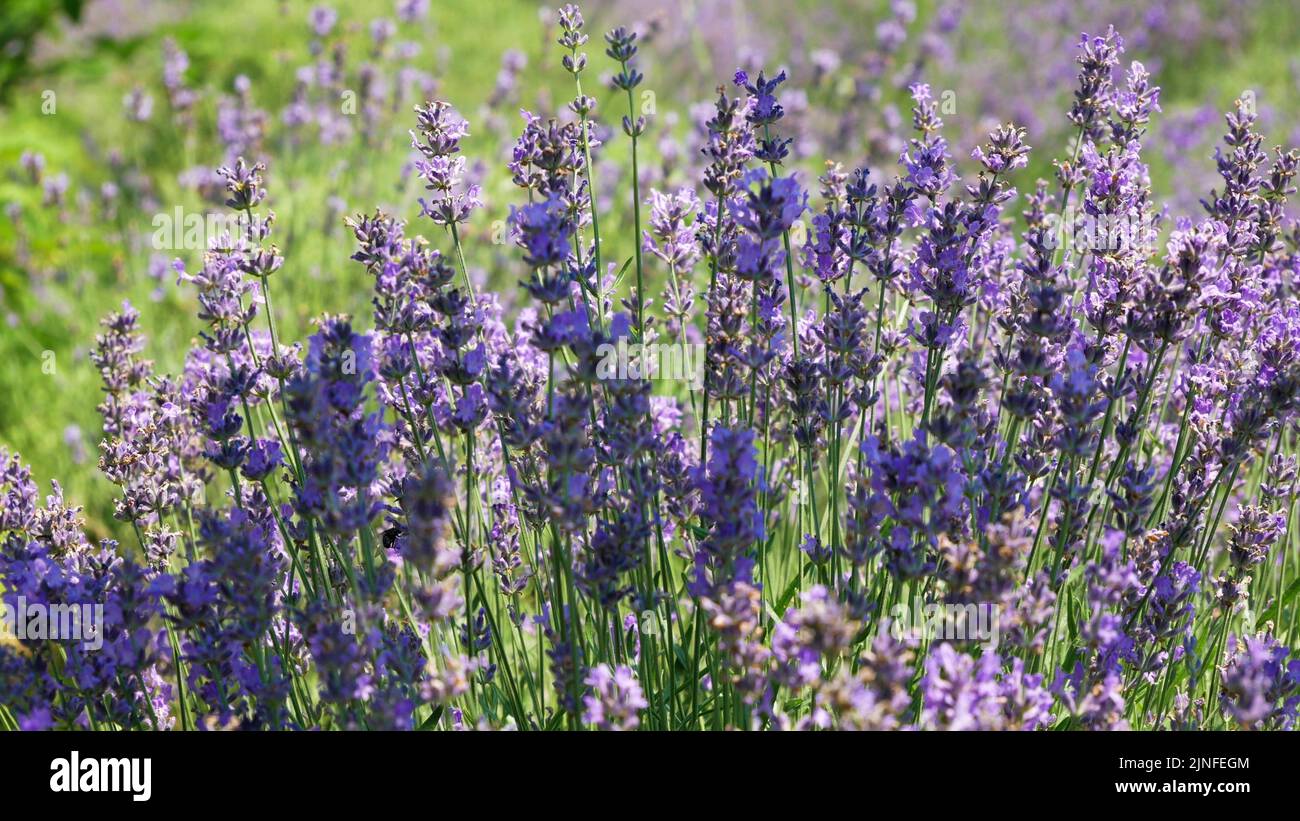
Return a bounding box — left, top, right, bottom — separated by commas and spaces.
0, 6, 1300, 730
